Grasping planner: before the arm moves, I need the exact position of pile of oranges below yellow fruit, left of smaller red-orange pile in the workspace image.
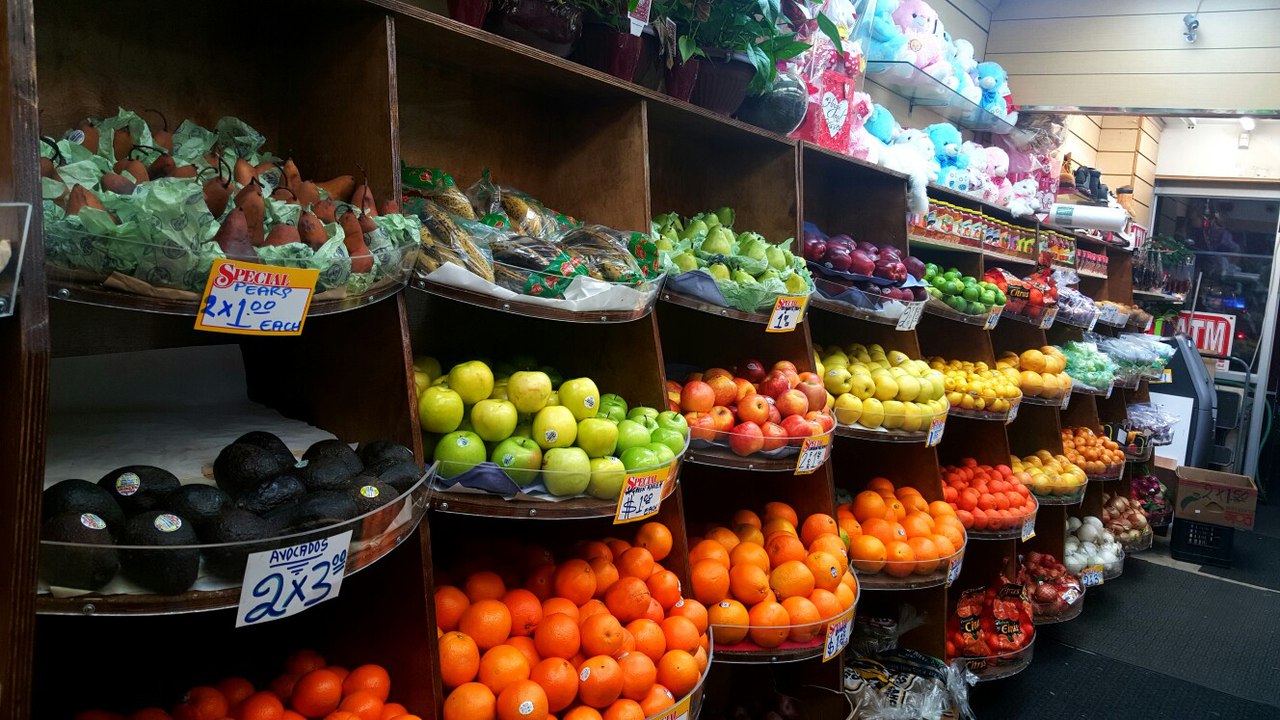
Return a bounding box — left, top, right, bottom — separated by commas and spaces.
836, 478, 965, 578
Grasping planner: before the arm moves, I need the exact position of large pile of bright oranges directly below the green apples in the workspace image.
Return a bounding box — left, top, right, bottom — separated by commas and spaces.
435, 523, 710, 720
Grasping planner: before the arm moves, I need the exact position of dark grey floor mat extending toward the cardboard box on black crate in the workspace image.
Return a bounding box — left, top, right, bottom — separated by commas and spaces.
1032, 559, 1280, 702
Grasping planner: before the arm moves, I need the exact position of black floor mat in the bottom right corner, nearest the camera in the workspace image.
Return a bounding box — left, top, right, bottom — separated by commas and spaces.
970, 635, 1280, 720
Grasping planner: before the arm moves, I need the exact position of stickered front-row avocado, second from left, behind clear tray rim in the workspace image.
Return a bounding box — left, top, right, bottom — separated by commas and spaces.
120, 510, 200, 594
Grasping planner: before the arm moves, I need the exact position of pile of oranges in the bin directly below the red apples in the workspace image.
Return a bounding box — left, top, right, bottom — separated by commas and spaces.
689, 502, 858, 648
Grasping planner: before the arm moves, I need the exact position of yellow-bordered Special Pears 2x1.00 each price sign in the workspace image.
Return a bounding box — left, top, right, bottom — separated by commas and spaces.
196, 259, 320, 336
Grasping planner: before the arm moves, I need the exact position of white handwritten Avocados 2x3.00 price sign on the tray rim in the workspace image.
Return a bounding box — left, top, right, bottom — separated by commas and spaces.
236, 530, 351, 628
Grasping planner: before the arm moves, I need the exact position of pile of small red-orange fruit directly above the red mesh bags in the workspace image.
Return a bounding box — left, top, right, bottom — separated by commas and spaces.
942, 457, 1038, 530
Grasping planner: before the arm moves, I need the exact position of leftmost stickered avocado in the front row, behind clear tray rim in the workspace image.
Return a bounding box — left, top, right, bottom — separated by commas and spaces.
40, 509, 120, 591
